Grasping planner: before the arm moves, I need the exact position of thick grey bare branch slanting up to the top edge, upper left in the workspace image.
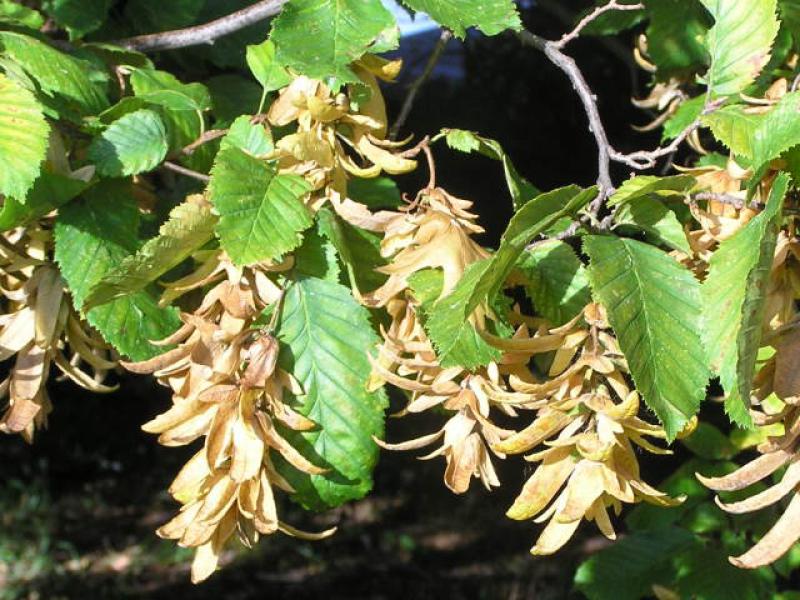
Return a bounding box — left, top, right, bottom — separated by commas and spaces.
113, 0, 288, 52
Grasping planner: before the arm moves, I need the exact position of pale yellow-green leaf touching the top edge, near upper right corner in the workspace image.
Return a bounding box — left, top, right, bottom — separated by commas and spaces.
701, 0, 779, 97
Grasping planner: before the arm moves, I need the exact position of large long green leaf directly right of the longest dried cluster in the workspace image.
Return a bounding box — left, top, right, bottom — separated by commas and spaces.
277, 279, 388, 509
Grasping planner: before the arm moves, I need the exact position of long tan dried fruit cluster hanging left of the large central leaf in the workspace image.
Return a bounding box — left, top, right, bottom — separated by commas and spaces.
125, 251, 333, 582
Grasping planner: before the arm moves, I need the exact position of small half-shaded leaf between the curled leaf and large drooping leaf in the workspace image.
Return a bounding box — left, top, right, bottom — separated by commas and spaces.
517, 240, 592, 326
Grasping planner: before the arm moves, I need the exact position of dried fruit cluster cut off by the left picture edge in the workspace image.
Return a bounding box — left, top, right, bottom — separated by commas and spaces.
0, 219, 116, 442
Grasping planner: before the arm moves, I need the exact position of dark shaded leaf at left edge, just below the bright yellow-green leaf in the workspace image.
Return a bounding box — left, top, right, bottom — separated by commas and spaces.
0, 171, 89, 231
